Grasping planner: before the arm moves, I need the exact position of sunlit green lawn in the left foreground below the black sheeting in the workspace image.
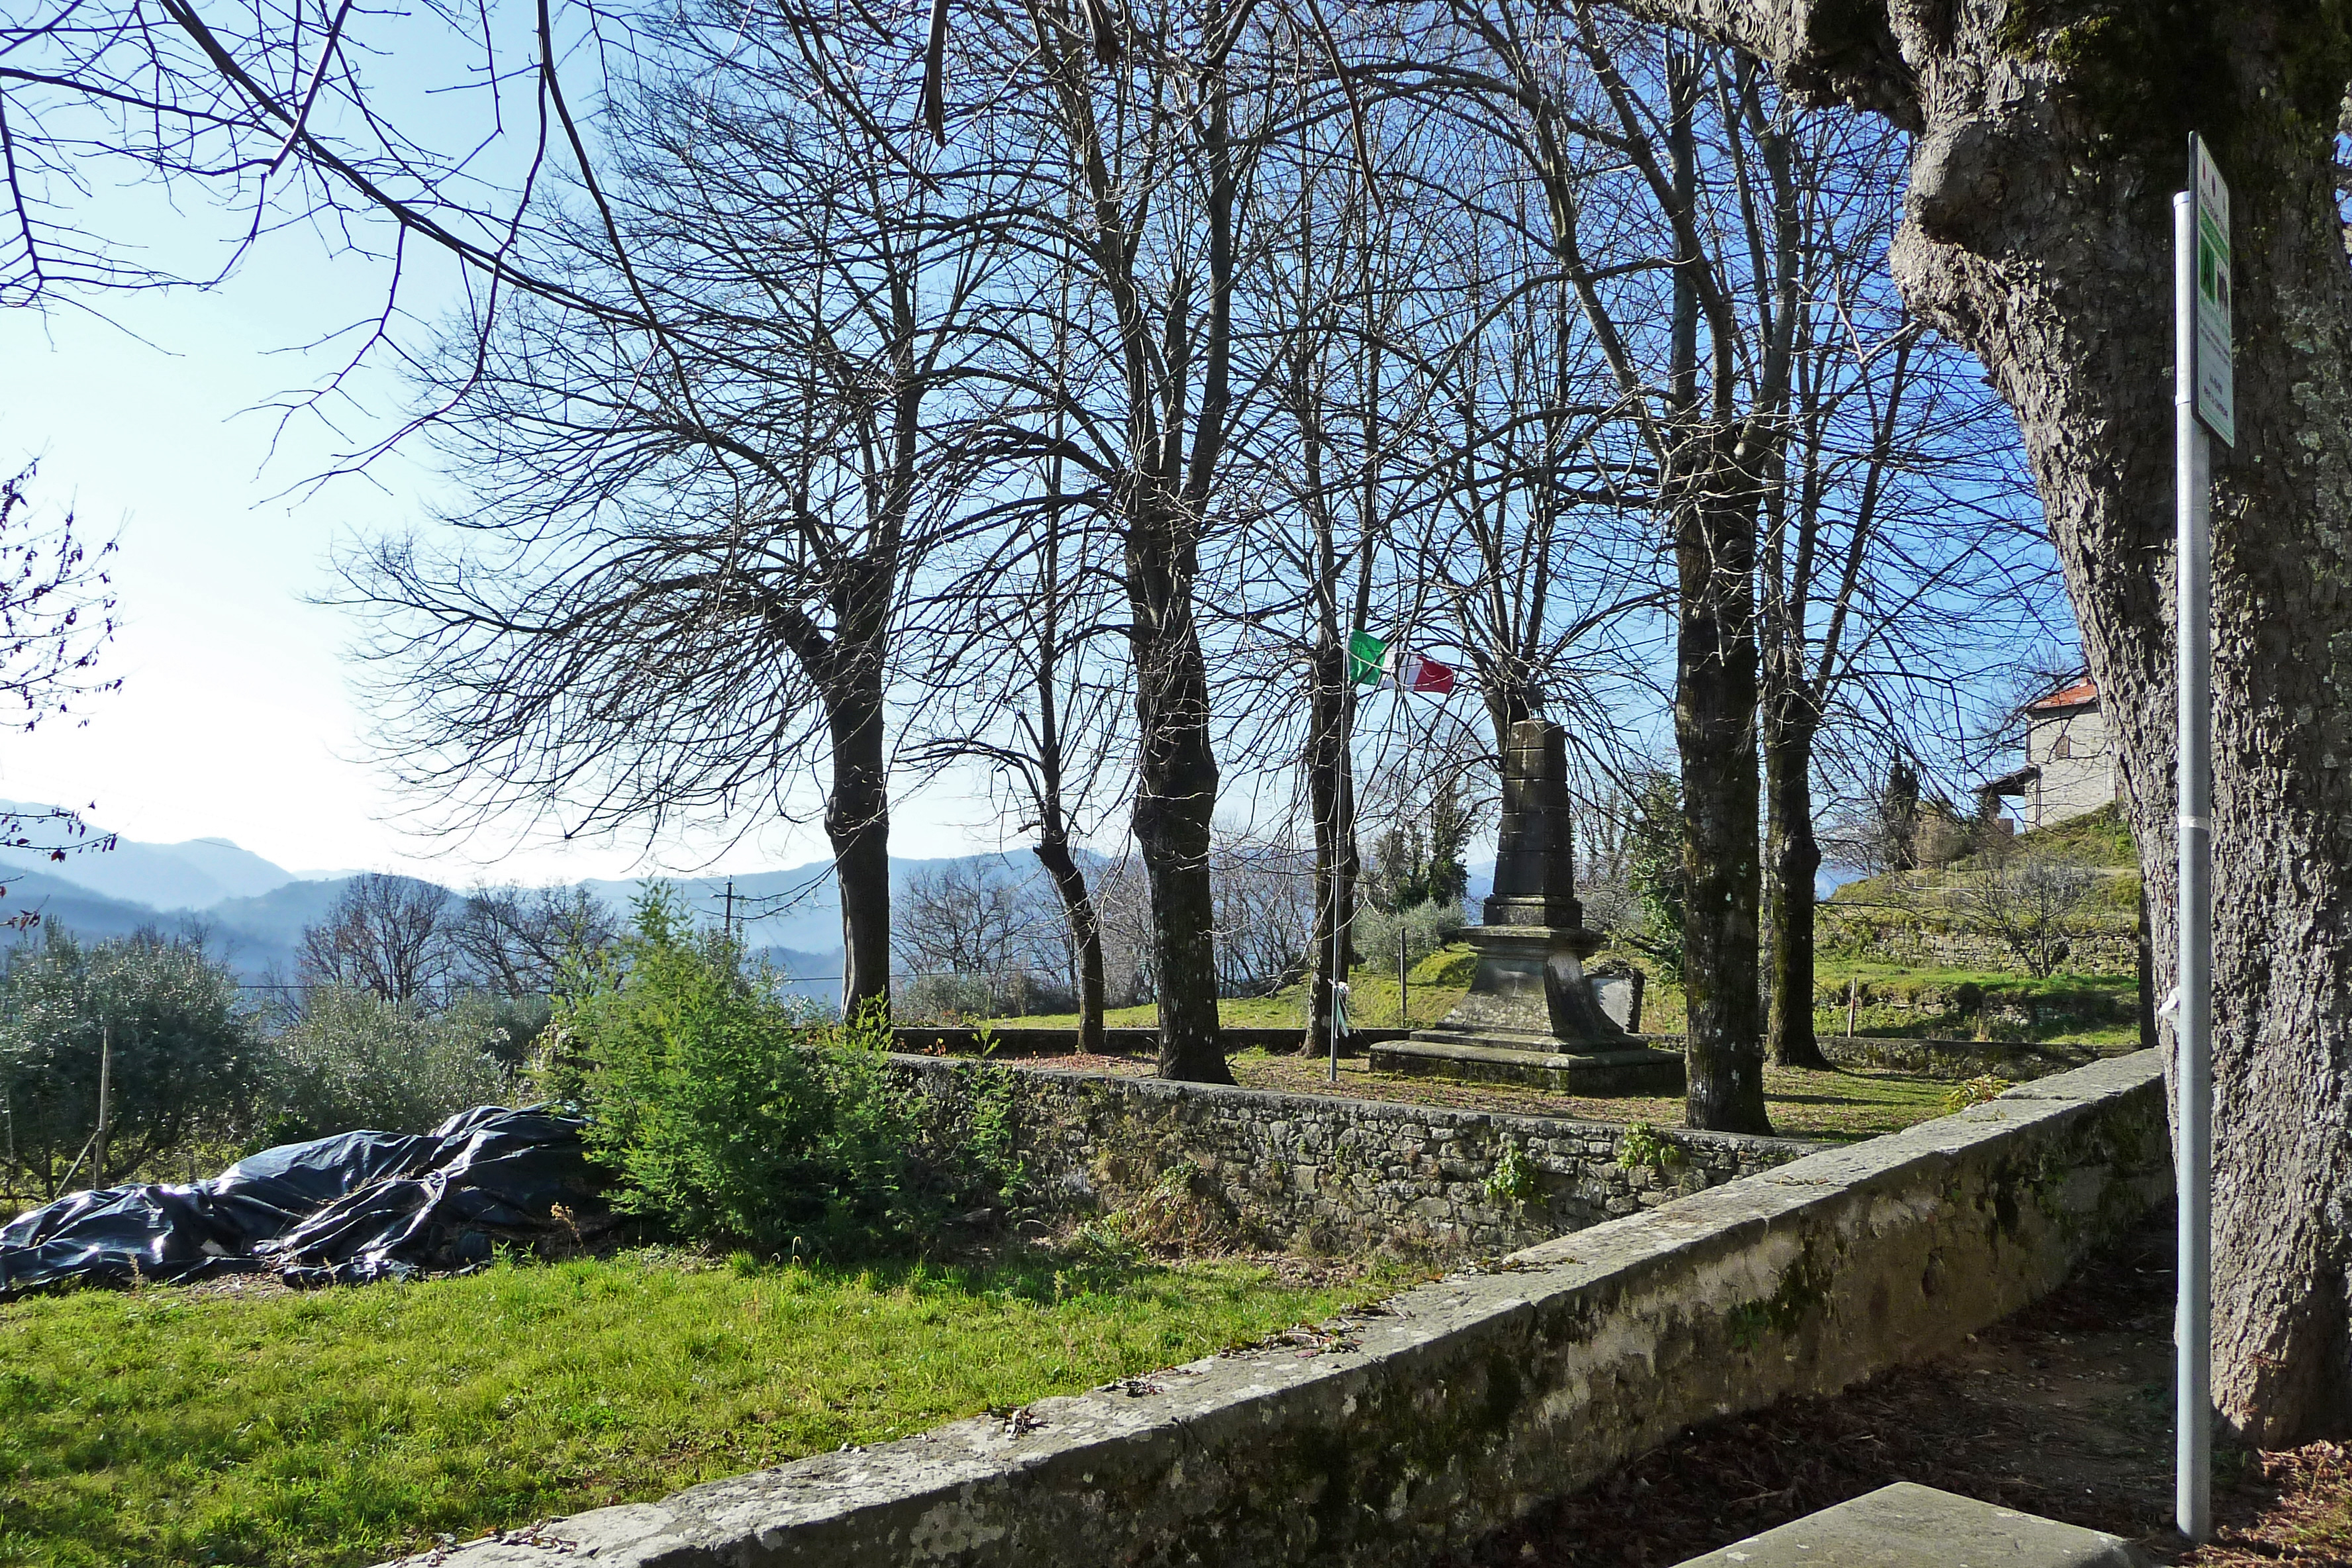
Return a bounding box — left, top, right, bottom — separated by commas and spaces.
0, 1253, 1362, 1568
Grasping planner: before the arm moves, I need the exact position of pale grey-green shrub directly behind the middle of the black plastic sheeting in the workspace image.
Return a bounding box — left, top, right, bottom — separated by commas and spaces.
264, 985, 515, 1142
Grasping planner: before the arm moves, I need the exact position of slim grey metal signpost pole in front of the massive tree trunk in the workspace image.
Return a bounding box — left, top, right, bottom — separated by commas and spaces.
2173, 152, 2228, 1542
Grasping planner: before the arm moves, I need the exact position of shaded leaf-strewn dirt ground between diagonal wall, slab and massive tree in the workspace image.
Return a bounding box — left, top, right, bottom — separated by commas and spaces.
1458, 1210, 2352, 1568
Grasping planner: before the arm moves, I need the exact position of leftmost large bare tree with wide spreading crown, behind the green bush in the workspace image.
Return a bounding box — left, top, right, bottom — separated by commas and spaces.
348, 9, 1004, 1008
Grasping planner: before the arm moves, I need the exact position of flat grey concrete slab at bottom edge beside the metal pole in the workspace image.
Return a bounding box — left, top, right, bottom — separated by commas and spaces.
1679, 1481, 2147, 1568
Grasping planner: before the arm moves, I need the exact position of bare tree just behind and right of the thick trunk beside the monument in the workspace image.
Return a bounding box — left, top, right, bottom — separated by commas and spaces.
1757, 115, 2063, 1067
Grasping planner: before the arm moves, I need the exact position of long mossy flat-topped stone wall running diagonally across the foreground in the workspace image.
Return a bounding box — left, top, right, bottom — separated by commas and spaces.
416, 1051, 2171, 1568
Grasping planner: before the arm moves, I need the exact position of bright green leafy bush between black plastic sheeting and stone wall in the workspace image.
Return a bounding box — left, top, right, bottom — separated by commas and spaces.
546, 886, 1018, 1253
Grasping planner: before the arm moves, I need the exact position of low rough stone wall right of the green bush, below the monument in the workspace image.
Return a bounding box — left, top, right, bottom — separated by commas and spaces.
894, 1055, 1820, 1253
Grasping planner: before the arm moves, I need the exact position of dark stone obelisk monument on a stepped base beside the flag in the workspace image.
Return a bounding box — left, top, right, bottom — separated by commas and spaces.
1371, 719, 1684, 1095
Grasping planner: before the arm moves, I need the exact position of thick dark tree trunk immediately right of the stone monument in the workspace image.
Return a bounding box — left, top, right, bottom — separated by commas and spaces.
1675, 482, 1771, 1133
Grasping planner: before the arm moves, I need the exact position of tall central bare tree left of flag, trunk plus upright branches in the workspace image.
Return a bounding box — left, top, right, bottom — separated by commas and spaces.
964, 0, 1279, 1084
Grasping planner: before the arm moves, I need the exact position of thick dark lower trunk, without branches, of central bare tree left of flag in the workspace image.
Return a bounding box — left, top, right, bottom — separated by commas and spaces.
1126, 505, 1232, 1084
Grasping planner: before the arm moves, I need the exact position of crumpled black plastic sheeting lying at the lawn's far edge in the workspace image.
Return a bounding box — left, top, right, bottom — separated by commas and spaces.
0, 1105, 595, 1300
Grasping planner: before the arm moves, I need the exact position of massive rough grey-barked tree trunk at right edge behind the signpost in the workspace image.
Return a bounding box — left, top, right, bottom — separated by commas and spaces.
1640, 0, 2352, 1446
